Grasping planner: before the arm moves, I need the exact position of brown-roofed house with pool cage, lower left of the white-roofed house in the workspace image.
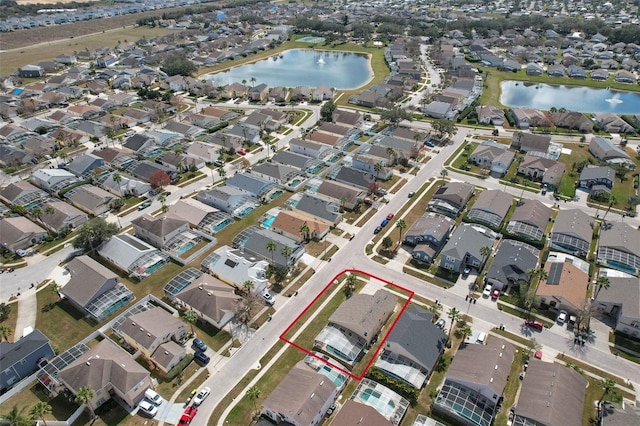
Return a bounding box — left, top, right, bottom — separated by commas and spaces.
60, 256, 134, 322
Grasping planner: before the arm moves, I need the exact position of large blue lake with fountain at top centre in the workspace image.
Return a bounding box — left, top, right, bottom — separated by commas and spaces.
205, 49, 373, 89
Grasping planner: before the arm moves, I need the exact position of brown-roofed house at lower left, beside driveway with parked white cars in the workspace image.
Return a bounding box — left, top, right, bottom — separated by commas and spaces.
59, 339, 153, 410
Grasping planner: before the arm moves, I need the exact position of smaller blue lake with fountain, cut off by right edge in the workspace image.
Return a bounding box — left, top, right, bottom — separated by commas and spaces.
500, 81, 640, 114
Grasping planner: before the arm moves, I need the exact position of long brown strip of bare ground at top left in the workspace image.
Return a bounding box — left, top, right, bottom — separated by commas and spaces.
0, 4, 190, 51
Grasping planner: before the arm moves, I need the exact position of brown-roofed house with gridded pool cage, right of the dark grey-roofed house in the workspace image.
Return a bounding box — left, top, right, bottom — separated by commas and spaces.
433, 336, 516, 426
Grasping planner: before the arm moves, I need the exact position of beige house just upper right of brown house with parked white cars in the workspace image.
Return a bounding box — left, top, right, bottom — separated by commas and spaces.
117, 307, 187, 373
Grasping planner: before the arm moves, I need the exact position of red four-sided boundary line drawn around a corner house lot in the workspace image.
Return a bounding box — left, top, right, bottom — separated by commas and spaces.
280, 269, 415, 381
